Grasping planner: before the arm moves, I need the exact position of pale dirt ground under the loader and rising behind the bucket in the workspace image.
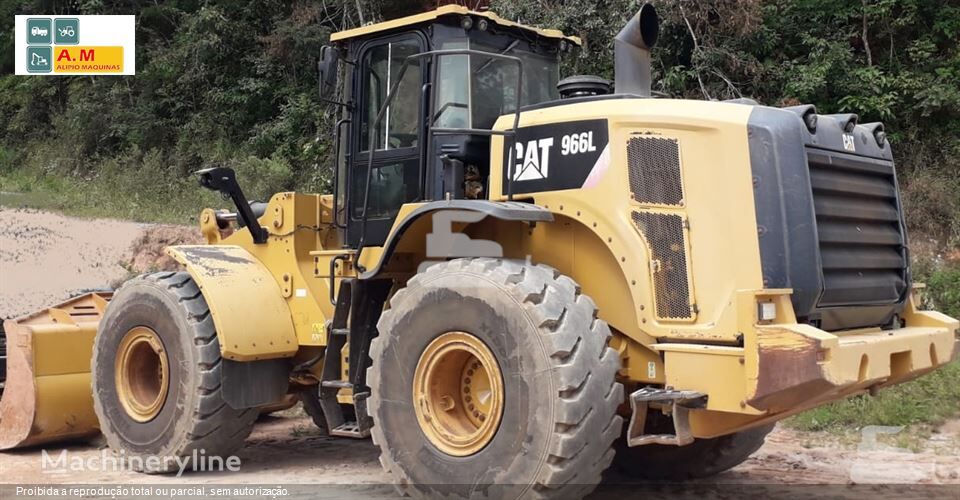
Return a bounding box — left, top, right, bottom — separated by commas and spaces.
0, 208, 960, 496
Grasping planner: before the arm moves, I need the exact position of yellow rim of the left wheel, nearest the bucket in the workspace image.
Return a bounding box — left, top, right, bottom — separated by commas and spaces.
114, 326, 170, 422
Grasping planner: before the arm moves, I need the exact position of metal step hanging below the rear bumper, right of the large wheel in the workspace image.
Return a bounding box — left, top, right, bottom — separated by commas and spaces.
627, 387, 707, 446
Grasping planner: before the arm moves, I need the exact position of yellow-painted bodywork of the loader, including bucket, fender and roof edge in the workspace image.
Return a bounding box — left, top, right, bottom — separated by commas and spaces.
0, 7, 960, 448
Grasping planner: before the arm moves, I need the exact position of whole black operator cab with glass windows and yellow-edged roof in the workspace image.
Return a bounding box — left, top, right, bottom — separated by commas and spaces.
320, 6, 580, 248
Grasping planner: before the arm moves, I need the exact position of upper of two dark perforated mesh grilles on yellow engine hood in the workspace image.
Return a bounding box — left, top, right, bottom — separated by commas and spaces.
627, 137, 683, 206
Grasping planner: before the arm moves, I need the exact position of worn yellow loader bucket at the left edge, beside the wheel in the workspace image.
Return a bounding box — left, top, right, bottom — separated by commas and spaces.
0, 292, 112, 450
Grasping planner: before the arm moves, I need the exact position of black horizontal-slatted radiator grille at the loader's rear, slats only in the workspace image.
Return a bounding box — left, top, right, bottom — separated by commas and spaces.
807, 148, 908, 307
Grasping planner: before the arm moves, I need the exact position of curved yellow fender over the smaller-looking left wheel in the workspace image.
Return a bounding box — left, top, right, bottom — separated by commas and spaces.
166, 245, 299, 361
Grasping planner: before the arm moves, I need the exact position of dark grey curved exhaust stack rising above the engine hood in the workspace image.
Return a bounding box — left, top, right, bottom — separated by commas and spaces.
613, 3, 660, 97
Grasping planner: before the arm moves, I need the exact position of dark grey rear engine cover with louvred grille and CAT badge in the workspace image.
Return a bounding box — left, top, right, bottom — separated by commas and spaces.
748, 106, 910, 330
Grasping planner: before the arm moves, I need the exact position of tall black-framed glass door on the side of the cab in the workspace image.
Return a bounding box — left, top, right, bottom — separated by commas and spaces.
347, 33, 427, 247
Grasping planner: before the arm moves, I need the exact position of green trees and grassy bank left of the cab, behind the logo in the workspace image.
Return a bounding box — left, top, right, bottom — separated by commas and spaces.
0, 1, 340, 222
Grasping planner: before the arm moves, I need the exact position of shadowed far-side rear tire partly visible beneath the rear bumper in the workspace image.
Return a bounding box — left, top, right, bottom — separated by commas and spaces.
613, 424, 773, 481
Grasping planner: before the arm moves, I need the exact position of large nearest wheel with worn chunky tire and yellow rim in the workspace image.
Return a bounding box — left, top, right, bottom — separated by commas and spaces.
367, 259, 623, 498
